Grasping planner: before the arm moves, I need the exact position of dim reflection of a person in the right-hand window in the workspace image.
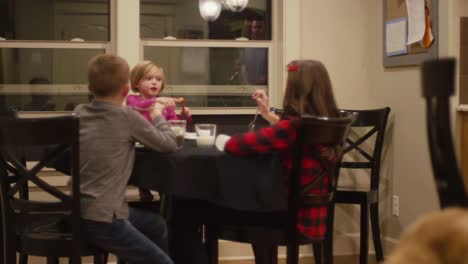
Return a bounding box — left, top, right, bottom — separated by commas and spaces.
240, 16, 268, 85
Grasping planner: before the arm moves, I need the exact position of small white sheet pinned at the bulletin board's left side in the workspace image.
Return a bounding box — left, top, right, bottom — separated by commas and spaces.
385, 17, 408, 56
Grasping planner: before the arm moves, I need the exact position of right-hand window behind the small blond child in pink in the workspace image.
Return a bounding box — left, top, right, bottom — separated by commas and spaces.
140, 0, 273, 109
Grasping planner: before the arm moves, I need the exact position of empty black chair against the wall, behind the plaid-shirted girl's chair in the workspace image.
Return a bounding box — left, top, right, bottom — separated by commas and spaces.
328, 107, 390, 263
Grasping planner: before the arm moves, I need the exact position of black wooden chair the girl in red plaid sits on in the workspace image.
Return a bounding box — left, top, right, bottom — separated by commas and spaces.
206, 116, 354, 264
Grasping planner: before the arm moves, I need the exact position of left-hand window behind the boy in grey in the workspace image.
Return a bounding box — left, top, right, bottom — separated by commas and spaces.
0, 0, 110, 111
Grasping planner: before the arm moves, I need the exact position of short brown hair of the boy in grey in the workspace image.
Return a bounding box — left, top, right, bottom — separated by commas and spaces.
88, 54, 130, 97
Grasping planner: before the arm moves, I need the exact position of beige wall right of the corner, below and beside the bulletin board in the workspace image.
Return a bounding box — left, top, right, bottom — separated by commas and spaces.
368, 1, 438, 239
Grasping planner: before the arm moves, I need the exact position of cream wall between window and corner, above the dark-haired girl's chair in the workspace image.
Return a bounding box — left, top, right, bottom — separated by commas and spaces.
301, 0, 372, 108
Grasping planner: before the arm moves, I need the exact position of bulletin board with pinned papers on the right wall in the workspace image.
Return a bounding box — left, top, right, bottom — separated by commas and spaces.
382, 0, 439, 67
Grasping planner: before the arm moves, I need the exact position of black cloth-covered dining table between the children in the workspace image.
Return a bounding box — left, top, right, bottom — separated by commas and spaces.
130, 139, 286, 212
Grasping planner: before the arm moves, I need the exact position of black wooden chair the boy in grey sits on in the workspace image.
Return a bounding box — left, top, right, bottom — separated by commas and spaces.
0, 116, 103, 264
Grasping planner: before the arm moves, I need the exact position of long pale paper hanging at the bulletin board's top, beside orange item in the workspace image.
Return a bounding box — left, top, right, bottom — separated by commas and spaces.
406, 0, 426, 45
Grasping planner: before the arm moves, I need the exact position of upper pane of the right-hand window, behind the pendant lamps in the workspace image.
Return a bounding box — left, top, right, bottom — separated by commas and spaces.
140, 0, 272, 40
